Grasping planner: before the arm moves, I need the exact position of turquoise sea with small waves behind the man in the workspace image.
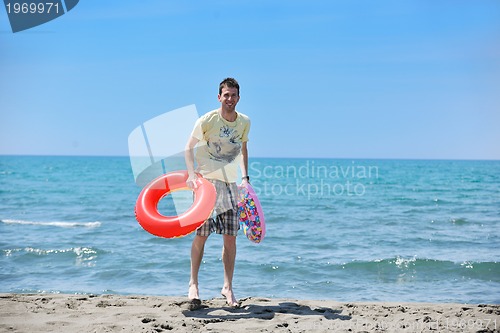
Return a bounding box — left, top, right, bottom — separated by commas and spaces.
0, 156, 500, 304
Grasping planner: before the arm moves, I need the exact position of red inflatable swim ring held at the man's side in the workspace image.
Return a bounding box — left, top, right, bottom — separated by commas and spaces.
135, 171, 216, 238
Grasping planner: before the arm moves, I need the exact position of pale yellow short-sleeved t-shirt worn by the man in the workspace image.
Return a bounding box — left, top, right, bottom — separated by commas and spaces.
191, 110, 250, 182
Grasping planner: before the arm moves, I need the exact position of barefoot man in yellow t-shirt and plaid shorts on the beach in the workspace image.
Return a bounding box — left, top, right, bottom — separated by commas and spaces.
185, 78, 250, 308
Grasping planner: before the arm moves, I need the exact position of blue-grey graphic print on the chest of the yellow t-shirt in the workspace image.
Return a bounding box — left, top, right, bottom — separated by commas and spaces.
207, 125, 241, 163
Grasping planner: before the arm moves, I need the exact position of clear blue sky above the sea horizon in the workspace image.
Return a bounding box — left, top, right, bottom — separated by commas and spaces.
0, 0, 500, 159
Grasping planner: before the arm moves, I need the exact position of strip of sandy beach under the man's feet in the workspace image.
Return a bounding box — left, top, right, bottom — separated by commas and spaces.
0, 294, 500, 333
